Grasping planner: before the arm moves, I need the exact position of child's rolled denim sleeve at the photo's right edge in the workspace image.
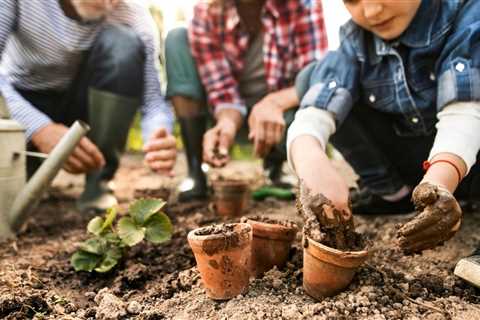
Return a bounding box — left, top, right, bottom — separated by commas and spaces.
437, 1, 480, 111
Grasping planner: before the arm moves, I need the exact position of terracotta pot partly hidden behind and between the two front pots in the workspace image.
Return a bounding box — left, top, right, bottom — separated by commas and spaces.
246, 219, 297, 278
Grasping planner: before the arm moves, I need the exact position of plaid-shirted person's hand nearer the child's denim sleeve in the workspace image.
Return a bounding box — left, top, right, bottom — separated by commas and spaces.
248, 95, 285, 158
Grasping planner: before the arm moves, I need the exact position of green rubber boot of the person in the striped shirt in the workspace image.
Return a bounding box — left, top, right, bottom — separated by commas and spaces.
77, 88, 140, 212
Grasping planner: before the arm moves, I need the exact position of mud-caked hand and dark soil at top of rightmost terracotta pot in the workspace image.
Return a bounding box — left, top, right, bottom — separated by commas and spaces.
297, 186, 366, 251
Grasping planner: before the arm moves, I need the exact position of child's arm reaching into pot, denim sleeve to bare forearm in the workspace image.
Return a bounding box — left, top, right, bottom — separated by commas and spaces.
287, 43, 359, 212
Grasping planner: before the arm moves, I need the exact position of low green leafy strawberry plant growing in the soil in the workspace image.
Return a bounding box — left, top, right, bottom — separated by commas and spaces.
70, 199, 173, 273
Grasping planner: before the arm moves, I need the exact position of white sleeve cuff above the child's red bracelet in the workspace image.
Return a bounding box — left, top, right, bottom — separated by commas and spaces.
428, 102, 480, 174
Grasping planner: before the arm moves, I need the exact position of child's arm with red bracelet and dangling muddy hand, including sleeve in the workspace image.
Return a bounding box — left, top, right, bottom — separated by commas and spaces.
399, 1, 480, 252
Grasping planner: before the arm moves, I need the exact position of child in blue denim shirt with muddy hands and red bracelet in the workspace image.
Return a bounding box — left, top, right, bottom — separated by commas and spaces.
287, 0, 480, 272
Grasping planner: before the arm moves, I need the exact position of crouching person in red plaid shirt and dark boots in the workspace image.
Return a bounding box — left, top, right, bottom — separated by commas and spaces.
165, 0, 327, 201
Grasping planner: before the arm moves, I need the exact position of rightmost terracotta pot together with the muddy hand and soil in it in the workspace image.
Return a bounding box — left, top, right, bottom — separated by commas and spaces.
297, 188, 368, 300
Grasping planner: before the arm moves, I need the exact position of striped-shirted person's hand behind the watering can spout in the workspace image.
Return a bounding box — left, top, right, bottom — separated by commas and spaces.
32, 123, 105, 174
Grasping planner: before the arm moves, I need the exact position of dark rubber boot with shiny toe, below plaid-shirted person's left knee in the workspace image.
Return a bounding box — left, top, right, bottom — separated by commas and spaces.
178, 114, 208, 202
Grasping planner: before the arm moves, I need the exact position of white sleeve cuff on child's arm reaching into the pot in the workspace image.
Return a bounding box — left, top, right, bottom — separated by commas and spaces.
287, 107, 336, 171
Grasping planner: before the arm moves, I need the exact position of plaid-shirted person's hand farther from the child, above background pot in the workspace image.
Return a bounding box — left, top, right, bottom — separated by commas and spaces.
203, 117, 238, 167
